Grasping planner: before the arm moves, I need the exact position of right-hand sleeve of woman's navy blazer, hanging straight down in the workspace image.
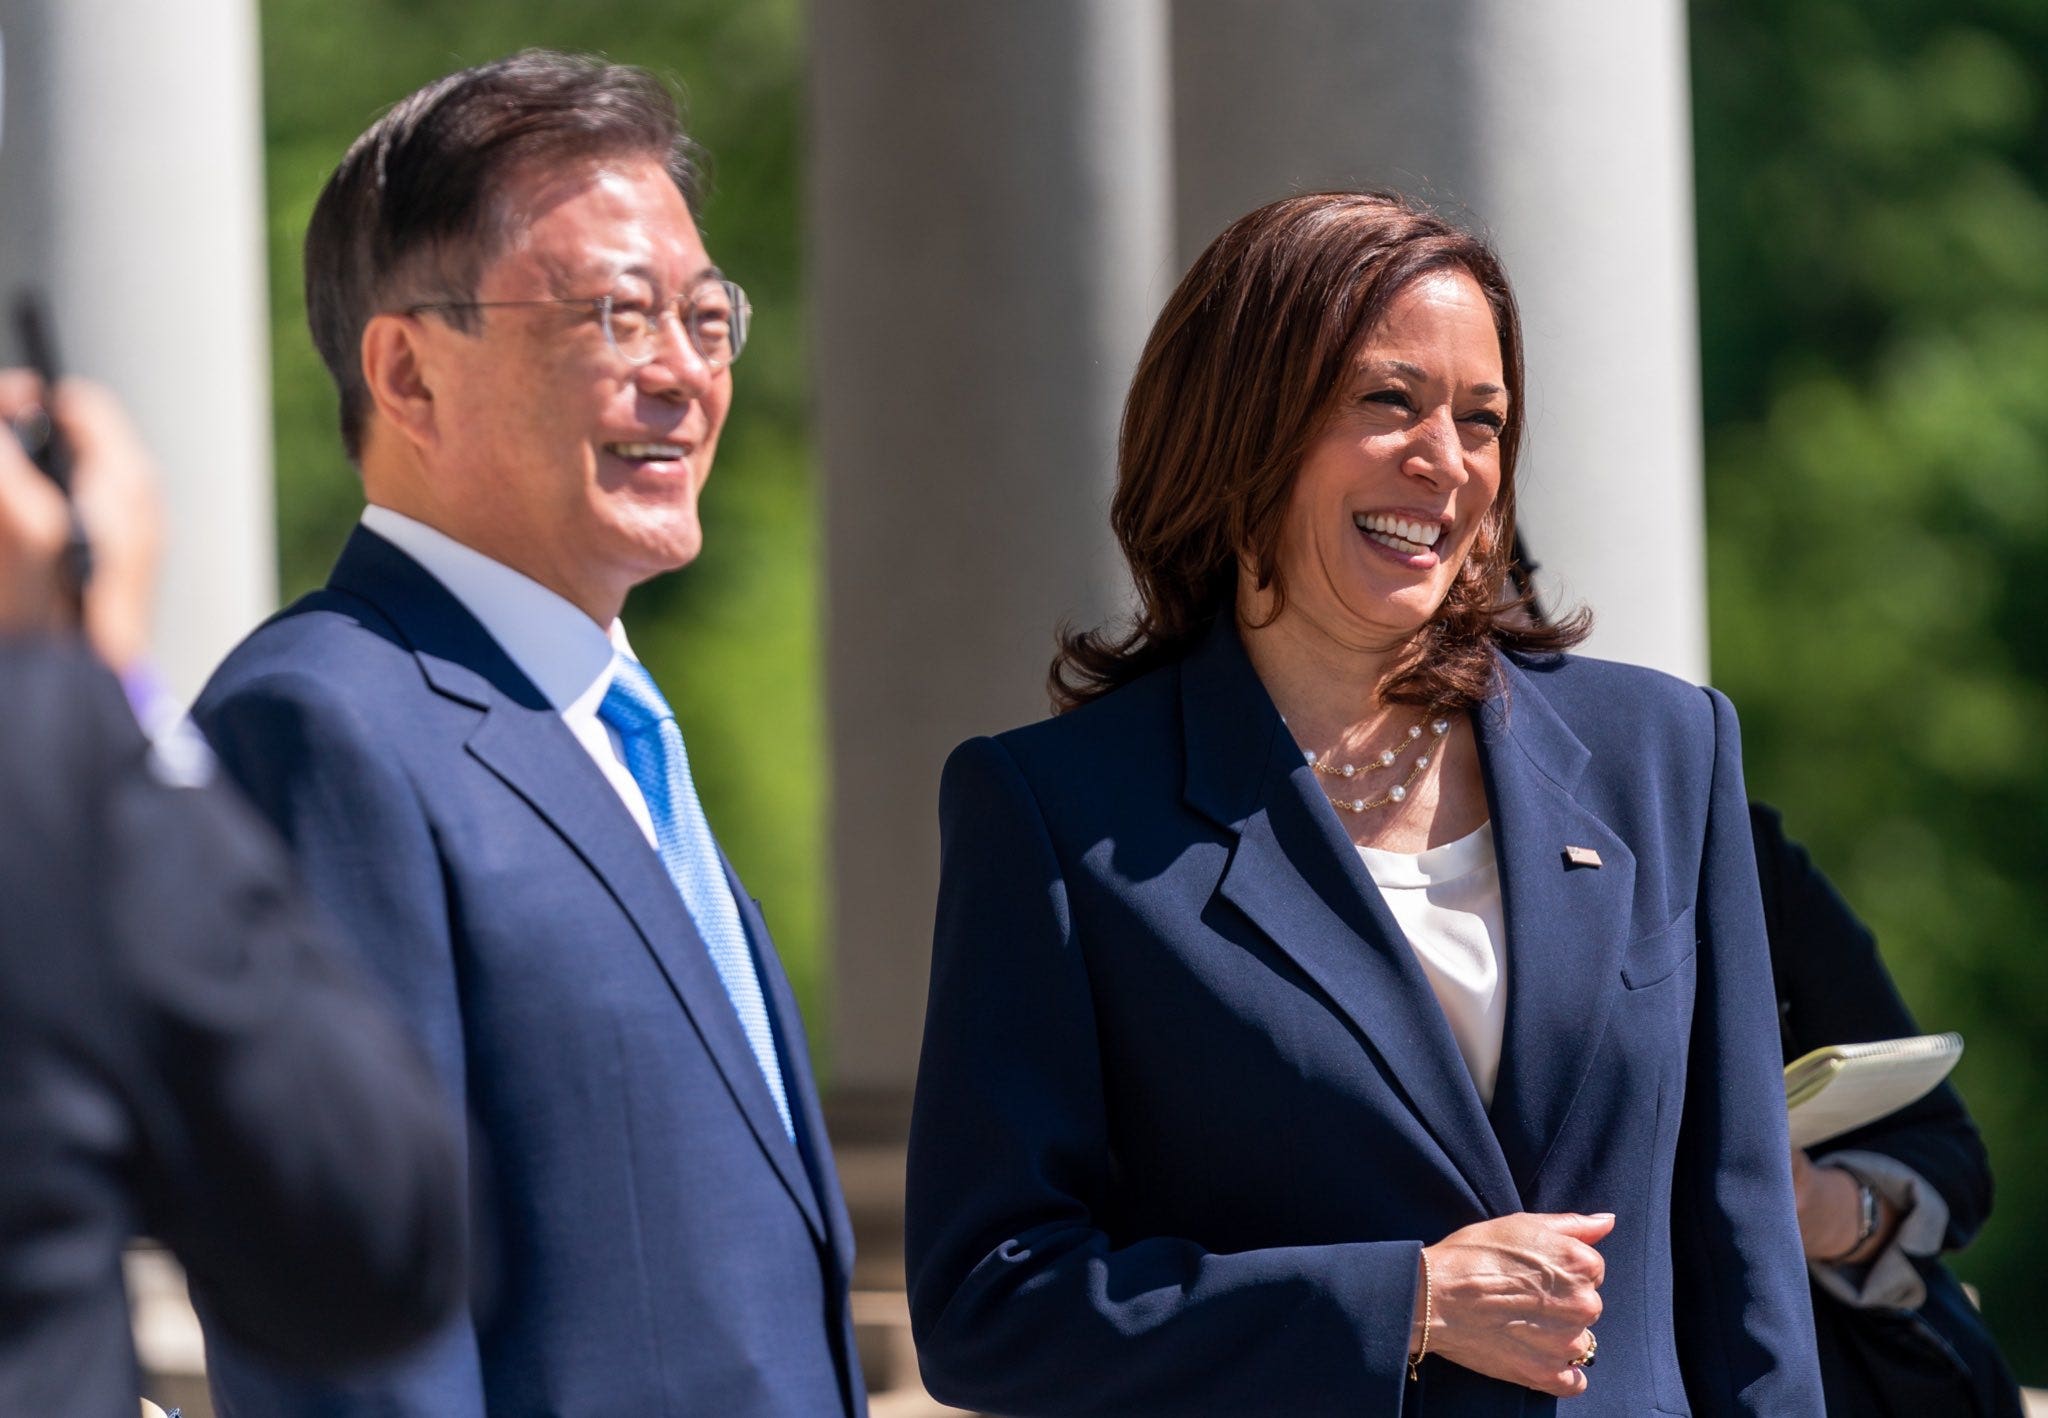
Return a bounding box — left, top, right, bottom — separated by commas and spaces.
1671, 691, 1823, 1418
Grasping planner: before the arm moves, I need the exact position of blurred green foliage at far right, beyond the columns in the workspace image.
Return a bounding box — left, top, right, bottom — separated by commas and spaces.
1692, 0, 2048, 1383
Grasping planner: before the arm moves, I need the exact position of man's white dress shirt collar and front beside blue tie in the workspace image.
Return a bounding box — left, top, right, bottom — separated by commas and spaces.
362, 504, 655, 846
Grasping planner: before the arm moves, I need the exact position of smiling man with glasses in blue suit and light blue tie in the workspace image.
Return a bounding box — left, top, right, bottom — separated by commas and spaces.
197, 51, 866, 1418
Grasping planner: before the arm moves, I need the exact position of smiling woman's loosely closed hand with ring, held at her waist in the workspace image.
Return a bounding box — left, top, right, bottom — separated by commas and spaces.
1423, 1211, 1614, 1398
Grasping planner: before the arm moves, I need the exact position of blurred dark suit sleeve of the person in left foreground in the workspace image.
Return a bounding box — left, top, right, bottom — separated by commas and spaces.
0, 643, 467, 1377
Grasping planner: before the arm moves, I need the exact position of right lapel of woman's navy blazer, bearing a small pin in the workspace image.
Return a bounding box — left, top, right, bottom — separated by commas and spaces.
1473, 660, 1636, 1195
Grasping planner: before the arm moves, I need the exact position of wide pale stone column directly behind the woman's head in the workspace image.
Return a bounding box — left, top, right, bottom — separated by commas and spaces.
1174, 0, 1706, 678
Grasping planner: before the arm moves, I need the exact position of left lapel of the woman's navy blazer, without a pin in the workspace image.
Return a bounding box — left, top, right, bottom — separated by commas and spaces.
1182, 623, 1522, 1215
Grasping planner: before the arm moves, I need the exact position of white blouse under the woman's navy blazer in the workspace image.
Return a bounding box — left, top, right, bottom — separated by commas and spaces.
1358, 824, 1507, 1107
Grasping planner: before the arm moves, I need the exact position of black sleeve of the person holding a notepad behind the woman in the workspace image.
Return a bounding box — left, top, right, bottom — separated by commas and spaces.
1749, 803, 1991, 1250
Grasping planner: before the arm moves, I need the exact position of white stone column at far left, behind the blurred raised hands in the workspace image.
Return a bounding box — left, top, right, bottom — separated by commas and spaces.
0, 0, 276, 697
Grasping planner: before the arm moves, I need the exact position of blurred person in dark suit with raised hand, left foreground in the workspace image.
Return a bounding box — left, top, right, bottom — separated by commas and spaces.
0, 371, 465, 1418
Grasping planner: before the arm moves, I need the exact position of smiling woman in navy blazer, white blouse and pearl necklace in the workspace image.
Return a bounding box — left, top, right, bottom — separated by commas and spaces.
907, 193, 1821, 1418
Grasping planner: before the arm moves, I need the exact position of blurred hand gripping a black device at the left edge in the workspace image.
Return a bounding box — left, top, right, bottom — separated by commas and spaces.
0, 369, 162, 670
